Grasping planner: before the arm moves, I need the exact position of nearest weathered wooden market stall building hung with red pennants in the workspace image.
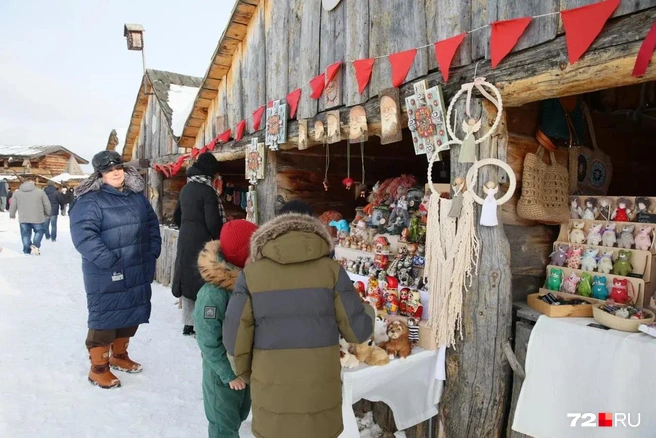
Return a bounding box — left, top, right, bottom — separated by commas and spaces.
136, 0, 656, 438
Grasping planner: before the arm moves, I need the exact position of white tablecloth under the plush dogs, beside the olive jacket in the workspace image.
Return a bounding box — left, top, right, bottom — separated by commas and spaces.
340, 348, 443, 438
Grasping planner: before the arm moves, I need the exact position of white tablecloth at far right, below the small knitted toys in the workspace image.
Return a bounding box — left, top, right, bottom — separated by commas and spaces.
512, 316, 656, 438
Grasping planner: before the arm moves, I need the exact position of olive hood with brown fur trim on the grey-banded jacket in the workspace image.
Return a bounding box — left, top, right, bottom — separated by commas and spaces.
251, 213, 333, 264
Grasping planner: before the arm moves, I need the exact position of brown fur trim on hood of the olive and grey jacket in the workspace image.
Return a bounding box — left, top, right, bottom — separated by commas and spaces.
251, 213, 334, 261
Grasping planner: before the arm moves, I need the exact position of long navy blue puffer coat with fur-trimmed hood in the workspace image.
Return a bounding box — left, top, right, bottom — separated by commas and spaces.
70, 167, 162, 330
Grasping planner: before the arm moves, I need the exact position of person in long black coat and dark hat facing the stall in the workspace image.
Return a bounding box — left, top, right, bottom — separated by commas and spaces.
172, 152, 225, 335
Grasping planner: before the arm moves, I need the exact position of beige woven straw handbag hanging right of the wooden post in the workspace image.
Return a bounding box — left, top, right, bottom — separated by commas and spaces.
517, 146, 569, 224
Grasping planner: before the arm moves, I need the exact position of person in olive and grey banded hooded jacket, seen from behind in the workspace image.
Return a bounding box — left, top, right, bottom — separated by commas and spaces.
223, 214, 375, 438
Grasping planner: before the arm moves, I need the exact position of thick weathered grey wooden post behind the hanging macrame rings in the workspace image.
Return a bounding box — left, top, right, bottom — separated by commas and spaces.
436, 99, 512, 438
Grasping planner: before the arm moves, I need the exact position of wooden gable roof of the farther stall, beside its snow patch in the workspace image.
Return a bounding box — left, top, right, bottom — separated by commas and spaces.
123, 69, 202, 161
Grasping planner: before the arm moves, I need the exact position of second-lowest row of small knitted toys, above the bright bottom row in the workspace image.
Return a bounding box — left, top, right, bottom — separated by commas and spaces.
550, 241, 654, 283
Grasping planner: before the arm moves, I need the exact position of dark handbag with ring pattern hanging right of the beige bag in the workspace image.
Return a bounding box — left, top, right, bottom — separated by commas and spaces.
569, 103, 613, 195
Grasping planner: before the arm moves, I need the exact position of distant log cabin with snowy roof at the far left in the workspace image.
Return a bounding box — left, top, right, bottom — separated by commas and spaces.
0, 145, 89, 190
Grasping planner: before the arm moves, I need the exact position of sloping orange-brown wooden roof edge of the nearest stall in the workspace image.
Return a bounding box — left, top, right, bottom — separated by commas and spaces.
178, 0, 260, 148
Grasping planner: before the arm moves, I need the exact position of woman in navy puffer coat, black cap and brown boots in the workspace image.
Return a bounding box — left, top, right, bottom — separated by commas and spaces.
70, 151, 162, 388
